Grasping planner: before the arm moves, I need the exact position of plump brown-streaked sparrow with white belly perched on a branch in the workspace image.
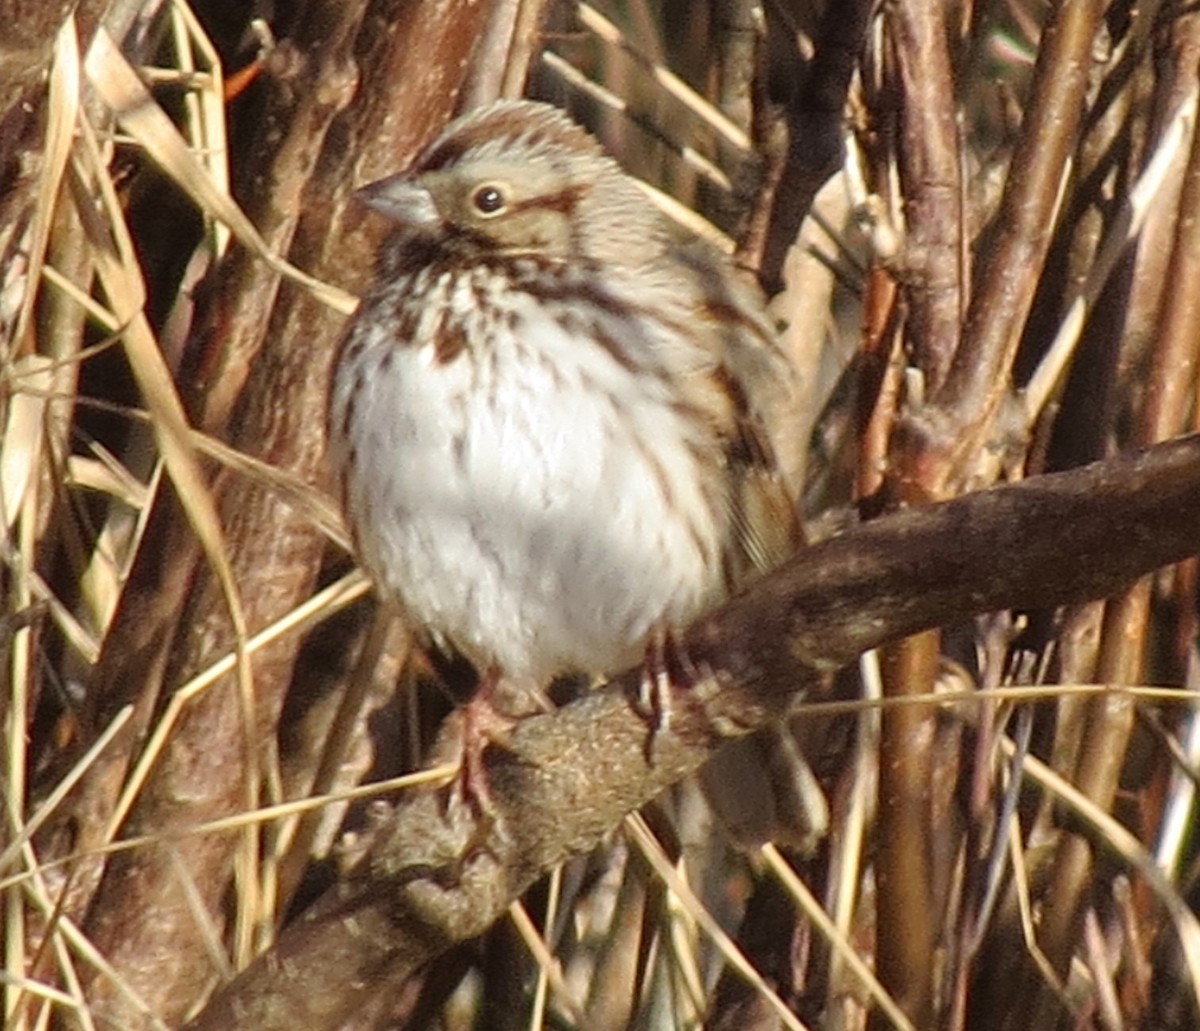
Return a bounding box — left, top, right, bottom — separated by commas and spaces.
329, 94, 816, 840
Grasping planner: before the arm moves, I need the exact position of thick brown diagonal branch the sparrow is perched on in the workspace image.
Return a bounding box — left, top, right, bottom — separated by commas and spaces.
182, 436, 1200, 1031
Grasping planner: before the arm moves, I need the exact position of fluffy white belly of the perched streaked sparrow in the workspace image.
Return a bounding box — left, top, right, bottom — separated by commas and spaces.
331, 270, 727, 681
